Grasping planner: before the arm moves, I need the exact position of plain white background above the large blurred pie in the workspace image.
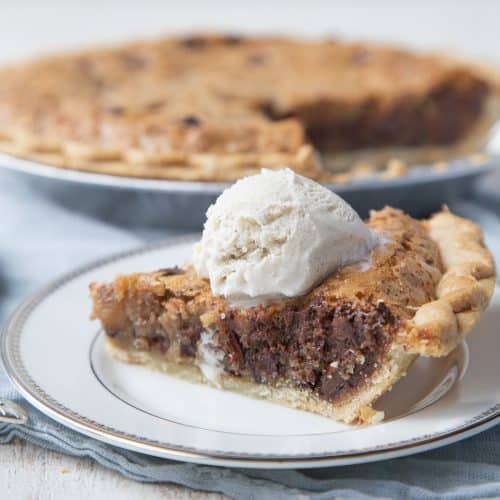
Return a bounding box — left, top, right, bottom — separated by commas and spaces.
0, 0, 500, 63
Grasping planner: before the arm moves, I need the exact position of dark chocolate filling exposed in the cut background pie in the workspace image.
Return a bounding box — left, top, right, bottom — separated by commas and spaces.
295, 76, 488, 153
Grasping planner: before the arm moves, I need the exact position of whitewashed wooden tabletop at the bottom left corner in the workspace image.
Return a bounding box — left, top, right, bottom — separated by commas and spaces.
0, 441, 224, 500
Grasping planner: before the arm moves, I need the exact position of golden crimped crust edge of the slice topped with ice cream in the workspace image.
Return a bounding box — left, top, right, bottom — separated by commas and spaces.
401, 210, 495, 356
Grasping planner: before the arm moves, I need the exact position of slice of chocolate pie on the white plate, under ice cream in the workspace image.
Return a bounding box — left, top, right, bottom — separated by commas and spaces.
90, 208, 495, 423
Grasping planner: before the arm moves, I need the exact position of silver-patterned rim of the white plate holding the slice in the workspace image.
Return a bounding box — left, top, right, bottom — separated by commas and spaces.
0, 233, 500, 468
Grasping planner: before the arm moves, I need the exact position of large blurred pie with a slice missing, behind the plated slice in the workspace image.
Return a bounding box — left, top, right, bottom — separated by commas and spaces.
0, 36, 499, 181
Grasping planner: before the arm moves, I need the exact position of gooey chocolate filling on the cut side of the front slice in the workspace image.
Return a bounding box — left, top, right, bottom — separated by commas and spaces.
95, 271, 398, 402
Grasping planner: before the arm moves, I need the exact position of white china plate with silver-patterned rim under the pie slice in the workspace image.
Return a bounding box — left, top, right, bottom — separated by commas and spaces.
1, 237, 500, 468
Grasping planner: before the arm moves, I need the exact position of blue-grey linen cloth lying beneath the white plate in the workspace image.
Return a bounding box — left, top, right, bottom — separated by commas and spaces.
0, 172, 500, 499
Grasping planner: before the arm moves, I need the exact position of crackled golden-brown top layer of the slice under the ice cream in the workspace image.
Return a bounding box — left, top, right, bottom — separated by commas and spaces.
92, 208, 442, 338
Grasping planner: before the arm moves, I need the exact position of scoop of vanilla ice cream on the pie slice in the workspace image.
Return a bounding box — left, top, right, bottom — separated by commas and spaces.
193, 169, 377, 303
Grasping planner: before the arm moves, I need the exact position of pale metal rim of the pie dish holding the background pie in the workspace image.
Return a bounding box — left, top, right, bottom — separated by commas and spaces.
0, 152, 500, 194
